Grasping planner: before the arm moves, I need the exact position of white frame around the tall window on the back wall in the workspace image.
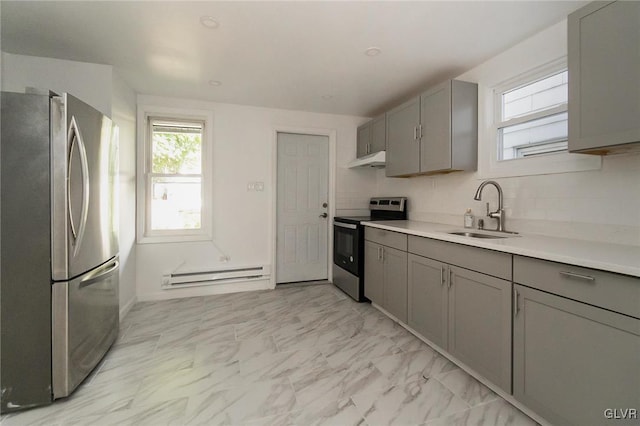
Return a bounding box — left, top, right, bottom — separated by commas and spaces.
136, 105, 213, 244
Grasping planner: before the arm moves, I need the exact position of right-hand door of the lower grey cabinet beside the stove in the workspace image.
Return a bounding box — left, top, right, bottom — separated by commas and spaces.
382, 246, 407, 324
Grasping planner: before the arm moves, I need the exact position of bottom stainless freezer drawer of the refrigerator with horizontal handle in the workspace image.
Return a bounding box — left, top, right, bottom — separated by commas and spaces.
52, 257, 120, 399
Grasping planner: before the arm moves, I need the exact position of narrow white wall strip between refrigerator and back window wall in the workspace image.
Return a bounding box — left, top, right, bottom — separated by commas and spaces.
111, 71, 136, 318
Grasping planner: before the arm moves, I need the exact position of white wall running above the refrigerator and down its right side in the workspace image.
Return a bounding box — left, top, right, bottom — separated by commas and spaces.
2, 52, 136, 313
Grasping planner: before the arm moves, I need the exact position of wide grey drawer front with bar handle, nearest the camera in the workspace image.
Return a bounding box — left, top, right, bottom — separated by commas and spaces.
513, 256, 640, 318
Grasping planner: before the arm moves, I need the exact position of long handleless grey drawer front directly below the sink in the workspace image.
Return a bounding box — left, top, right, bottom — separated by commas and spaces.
408, 235, 511, 280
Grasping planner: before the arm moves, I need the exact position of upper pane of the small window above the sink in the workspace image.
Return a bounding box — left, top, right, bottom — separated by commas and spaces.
502, 71, 568, 121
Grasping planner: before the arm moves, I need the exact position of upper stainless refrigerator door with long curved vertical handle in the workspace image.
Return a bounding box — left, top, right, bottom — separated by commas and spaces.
51, 94, 118, 281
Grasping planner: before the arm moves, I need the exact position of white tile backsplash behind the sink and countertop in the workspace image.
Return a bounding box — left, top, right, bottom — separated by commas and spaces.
376, 154, 640, 245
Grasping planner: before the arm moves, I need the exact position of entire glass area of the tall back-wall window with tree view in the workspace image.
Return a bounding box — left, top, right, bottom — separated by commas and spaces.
146, 118, 204, 234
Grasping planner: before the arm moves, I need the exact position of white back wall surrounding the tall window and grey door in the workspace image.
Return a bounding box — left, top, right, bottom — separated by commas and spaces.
136, 95, 376, 300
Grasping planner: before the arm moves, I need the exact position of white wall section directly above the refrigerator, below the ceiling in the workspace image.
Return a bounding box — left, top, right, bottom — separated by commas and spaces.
2, 52, 112, 117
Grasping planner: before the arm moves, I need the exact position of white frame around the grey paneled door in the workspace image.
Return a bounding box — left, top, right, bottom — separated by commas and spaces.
269, 126, 337, 288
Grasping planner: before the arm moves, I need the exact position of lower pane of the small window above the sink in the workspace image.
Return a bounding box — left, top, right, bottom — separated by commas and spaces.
498, 112, 567, 160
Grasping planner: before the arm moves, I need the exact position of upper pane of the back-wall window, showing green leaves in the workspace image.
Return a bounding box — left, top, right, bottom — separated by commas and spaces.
151, 121, 202, 174
